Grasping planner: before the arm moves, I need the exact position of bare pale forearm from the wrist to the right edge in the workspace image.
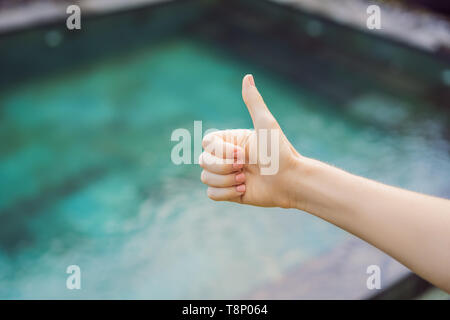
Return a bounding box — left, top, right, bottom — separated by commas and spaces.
289, 158, 450, 292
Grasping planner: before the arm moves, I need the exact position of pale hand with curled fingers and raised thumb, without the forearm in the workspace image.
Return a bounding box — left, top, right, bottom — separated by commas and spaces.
199, 75, 302, 208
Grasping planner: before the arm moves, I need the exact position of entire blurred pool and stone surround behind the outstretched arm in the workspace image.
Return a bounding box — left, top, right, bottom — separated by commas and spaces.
0, 0, 450, 299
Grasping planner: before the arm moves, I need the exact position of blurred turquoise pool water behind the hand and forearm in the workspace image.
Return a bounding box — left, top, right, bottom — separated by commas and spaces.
0, 38, 450, 299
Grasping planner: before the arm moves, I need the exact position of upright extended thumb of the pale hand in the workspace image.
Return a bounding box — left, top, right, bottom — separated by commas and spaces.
242, 74, 280, 129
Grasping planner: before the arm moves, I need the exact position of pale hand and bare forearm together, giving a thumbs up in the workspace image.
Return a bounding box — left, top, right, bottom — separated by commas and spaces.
199, 75, 450, 293
